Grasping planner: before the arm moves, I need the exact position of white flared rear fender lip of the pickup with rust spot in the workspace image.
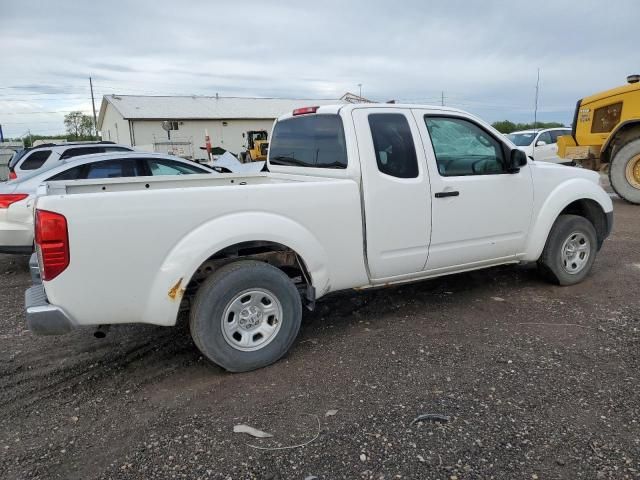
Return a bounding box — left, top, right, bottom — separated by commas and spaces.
143, 212, 329, 326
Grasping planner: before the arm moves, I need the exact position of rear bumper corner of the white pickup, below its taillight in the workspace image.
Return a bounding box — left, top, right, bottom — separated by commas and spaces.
24, 283, 75, 335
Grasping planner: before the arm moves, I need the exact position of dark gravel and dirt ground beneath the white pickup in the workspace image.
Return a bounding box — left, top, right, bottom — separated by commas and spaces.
0, 196, 640, 480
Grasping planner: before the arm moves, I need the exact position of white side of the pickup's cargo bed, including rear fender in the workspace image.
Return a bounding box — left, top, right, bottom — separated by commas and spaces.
36, 173, 368, 325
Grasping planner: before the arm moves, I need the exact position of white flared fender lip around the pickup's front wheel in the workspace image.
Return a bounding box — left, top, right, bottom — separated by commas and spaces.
523, 178, 613, 262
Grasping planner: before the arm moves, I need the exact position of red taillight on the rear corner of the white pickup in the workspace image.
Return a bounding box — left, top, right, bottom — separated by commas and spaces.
35, 210, 69, 280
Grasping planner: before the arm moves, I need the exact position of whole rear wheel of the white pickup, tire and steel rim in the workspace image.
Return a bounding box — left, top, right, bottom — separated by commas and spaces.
190, 260, 302, 372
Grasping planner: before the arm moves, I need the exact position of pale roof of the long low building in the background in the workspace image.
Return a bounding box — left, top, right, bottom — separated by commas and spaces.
98, 95, 344, 129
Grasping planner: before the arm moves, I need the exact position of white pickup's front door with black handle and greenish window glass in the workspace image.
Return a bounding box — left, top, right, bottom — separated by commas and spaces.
414, 110, 533, 273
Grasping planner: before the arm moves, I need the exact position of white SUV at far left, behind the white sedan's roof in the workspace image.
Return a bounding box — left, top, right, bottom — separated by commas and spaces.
9, 142, 133, 180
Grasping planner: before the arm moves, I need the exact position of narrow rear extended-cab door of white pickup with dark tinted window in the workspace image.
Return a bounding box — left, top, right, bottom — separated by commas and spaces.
353, 108, 431, 279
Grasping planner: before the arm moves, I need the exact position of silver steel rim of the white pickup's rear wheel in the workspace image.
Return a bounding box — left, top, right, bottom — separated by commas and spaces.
221, 288, 282, 352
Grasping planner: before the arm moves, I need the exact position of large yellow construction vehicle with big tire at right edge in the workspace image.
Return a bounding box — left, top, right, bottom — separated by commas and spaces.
558, 75, 640, 204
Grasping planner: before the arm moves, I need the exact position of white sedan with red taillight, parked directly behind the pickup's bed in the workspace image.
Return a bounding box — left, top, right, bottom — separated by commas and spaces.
0, 151, 215, 253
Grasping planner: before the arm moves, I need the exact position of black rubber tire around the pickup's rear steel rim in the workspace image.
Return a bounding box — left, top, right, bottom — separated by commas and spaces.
189, 260, 302, 372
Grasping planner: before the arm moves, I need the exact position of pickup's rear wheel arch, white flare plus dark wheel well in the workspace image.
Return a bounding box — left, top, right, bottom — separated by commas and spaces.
143, 212, 329, 326
